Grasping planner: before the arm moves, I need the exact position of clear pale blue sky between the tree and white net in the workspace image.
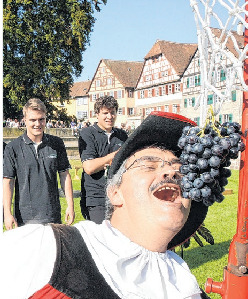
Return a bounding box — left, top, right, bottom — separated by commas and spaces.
74, 0, 234, 82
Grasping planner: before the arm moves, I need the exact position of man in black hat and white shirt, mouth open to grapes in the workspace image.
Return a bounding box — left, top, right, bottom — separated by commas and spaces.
3, 112, 208, 299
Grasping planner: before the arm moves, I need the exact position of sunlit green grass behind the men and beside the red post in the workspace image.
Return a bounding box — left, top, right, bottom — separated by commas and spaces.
3, 160, 239, 299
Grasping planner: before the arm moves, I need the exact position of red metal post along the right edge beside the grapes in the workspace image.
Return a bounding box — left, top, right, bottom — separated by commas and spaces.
205, 0, 248, 299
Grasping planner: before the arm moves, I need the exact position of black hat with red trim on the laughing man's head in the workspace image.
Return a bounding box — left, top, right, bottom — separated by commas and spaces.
108, 111, 208, 249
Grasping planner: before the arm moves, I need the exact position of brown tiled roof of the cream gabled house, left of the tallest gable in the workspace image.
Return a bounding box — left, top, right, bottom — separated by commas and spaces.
102, 59, 144, 87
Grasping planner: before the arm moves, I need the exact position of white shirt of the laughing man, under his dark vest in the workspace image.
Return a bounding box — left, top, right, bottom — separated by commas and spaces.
0, 221, 201, 299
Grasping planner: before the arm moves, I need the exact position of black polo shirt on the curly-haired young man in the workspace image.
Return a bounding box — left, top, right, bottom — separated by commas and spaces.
78, 123, 128, 206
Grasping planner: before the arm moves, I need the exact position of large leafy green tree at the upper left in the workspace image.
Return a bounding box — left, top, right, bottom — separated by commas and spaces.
3, 0, 107, 117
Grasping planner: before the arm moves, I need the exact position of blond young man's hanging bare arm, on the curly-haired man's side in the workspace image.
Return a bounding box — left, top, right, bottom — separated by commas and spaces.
59, 170, 75, 225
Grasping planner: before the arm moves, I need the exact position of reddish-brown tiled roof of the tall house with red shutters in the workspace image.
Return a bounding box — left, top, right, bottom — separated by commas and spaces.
145, 40, 198, 76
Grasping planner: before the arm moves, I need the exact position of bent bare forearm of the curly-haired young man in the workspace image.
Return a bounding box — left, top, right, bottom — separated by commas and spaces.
83, 151, 118, 175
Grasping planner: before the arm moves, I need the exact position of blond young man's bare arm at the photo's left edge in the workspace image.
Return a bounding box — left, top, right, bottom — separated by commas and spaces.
3, 178, 18, 230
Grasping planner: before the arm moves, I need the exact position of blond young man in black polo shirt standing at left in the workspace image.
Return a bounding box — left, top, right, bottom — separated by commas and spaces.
3, 98, 74, 230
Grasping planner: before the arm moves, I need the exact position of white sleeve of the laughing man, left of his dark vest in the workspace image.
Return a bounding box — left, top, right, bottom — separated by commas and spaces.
0, 224, 56, 299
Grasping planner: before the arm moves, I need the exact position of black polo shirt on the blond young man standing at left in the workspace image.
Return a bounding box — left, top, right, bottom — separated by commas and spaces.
3, 133, 71, 225
